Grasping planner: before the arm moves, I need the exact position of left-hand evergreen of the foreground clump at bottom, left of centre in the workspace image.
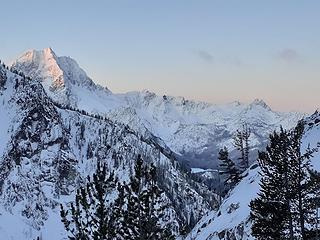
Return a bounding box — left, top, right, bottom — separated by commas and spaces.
60, 163, 116, 240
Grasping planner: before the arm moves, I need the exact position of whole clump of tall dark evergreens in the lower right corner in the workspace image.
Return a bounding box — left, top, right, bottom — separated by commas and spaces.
250, 122, 320, 239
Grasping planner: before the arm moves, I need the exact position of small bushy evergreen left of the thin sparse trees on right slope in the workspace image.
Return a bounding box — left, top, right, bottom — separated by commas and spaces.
218, 147, 241, 187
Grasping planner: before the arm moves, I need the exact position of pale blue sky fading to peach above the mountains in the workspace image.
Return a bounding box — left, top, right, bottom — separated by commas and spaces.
0, 0, 320, 112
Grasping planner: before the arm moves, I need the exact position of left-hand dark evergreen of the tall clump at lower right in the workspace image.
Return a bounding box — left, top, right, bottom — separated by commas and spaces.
250, 128, 292, 240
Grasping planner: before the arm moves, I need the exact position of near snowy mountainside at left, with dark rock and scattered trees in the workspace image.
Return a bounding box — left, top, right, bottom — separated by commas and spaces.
0, 62, 215, 240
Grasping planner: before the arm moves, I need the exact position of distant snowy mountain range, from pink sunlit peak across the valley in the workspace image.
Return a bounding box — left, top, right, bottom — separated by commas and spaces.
13, 48, 303, 168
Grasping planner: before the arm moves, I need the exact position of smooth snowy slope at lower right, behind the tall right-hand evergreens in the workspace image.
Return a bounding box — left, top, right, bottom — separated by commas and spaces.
186, 112, 320, 240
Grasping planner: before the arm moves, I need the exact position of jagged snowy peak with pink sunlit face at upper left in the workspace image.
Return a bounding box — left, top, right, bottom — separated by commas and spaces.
12, 48, 109, 106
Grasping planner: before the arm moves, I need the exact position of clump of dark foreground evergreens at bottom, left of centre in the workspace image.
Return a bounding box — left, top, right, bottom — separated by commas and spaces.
61, 155, 175, 240
